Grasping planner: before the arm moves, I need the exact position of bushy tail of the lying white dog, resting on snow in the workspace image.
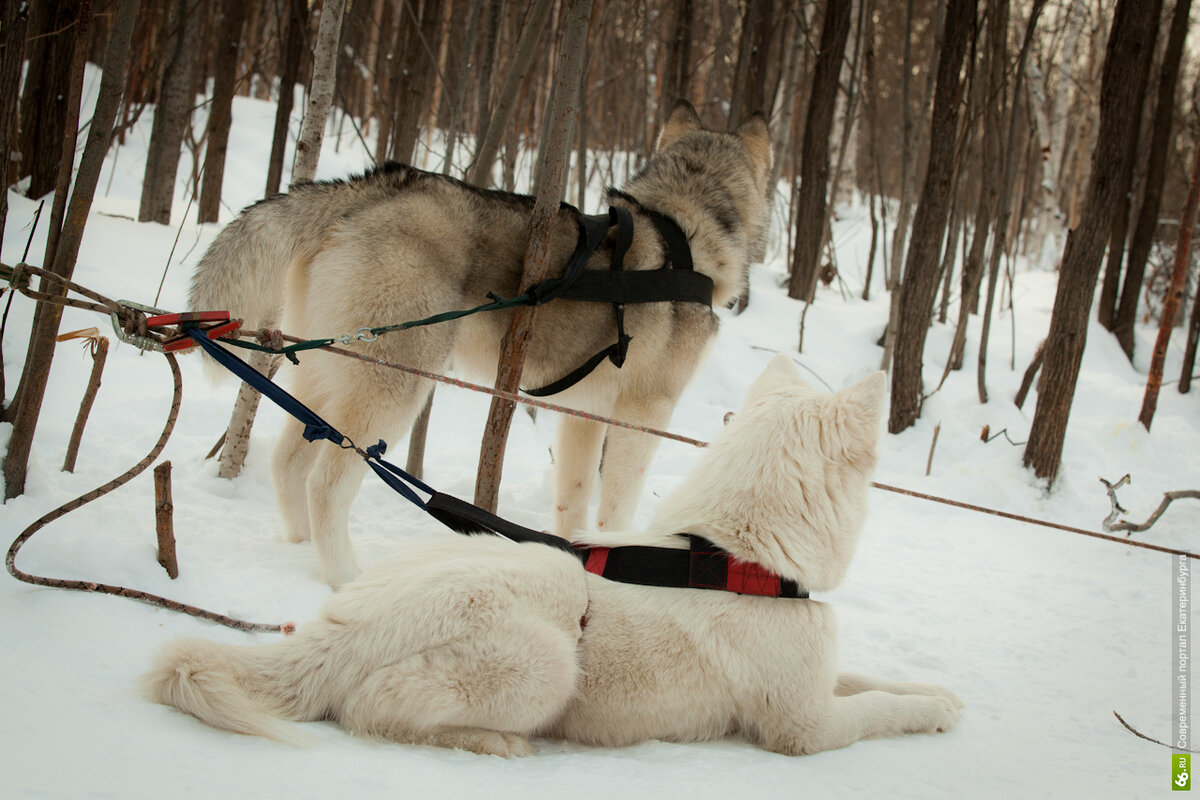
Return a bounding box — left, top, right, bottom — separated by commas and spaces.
143, 639, 311, 745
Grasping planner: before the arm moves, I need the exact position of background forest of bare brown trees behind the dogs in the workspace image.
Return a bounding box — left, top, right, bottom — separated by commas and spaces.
0, 0, 1200, 495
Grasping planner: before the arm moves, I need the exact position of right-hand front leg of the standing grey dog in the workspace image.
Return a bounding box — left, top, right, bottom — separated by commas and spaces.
596, 395, 678, 530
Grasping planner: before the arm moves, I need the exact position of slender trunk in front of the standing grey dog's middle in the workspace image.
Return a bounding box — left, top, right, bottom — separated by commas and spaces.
475, 0, 592, 511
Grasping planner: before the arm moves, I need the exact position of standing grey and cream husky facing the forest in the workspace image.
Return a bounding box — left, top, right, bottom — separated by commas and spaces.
190, 103, 770, 585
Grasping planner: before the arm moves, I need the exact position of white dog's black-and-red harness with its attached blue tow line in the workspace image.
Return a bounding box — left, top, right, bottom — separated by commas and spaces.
185, 326, 808, 599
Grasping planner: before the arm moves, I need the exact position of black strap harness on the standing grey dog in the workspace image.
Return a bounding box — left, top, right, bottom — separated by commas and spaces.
523, 205, 713, 397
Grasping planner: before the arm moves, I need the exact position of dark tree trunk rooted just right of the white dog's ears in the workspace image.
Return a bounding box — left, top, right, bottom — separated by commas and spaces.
888, 0, 976, 433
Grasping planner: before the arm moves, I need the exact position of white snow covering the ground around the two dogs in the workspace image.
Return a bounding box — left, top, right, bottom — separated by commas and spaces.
0, 71, 1200, 798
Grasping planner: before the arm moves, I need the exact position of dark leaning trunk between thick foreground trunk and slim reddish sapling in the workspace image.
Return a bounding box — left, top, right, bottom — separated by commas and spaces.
1109, 0, 1192, 360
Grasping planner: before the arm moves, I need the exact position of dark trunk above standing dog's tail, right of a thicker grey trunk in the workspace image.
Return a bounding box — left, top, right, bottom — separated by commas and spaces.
196, 0, 248, 222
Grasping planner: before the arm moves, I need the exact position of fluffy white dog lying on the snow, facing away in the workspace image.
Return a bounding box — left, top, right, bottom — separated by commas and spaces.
146, 356, 962, 756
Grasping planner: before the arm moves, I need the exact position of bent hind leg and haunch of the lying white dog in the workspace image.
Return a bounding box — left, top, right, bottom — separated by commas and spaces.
337, 614, 578, 756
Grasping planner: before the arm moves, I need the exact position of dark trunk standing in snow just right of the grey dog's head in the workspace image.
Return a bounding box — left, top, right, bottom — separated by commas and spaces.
787, 0, 851, 300
